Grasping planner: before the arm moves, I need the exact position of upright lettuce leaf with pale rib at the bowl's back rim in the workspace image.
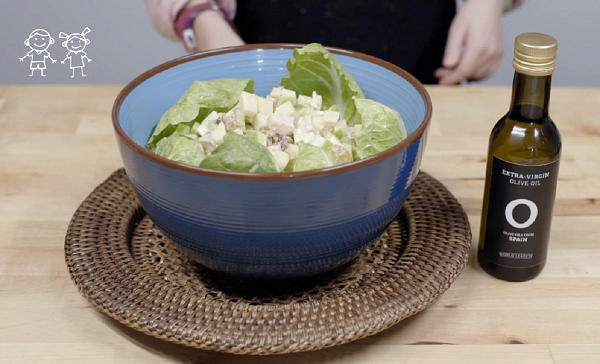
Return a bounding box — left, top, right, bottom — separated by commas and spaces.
281, 43, 365, 125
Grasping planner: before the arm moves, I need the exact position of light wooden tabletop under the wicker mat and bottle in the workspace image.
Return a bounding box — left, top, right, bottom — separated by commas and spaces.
0, 86, 600, 364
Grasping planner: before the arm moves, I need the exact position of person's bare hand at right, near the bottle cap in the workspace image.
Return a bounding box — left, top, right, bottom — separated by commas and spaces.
435, 0, 506, 85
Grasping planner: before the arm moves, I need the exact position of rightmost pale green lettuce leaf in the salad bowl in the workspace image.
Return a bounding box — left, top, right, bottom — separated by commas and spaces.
354, 98, 406, 159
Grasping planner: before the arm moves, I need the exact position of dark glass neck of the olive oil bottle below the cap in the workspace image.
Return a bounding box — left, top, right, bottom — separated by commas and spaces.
509, 72, 552, 122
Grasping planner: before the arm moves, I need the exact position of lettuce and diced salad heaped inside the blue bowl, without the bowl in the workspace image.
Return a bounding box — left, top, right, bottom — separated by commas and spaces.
146, 43, 407, 173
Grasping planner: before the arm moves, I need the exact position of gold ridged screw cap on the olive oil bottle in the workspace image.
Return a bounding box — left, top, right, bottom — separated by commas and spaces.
513, 33, 558, 76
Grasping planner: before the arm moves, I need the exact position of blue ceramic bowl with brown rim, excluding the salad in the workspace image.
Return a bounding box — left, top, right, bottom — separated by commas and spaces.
112, 44, 431, 280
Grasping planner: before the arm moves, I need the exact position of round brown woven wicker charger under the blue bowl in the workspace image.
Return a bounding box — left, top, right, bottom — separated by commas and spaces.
65, 169, 471, 354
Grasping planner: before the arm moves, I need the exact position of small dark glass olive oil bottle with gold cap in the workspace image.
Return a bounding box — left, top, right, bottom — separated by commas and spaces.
477, 33, 561, 282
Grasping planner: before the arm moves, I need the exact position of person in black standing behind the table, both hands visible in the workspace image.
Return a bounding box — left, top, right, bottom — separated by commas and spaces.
146, 0, 525, 84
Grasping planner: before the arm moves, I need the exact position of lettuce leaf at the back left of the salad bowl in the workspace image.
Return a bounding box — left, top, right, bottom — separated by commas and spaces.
146, 78, 254, 149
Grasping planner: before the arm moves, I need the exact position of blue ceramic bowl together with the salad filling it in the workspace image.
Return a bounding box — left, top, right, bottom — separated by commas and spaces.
113, 44, 431, 281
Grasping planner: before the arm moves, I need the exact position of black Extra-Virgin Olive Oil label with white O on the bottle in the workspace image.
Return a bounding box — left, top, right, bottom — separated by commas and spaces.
483, 156, 558, 268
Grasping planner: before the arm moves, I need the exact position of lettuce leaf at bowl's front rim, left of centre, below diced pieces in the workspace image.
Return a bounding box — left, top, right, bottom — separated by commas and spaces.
200, 131, 281, 173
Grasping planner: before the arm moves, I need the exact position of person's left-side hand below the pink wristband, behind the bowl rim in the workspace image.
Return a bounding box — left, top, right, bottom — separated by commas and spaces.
194, 11, 244, 51
